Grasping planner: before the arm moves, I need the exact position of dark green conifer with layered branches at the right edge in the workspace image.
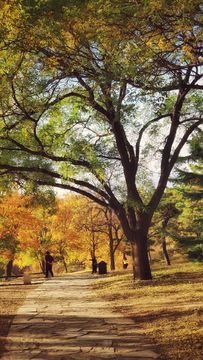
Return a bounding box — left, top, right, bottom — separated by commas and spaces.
173, 129, 203, 261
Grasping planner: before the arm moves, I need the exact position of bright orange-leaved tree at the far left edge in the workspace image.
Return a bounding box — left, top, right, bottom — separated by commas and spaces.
0, 192, 42, 277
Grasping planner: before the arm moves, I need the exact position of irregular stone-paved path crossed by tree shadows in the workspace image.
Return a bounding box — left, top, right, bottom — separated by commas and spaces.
2, 274, 157, 360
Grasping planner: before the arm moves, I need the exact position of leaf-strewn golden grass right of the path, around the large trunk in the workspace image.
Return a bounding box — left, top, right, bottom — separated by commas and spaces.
95, 263, 203, 360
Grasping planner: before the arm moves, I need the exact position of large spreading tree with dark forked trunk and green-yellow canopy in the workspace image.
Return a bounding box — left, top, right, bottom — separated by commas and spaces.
0, 0, 203, 279
